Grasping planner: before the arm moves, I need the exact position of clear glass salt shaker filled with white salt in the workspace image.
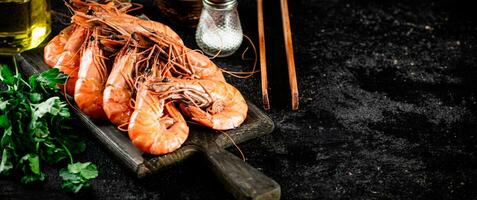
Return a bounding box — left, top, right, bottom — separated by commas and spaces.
195, 0, 243, 57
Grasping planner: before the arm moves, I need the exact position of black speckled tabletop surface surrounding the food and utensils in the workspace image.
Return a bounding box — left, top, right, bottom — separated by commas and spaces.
0, 0, 477, 199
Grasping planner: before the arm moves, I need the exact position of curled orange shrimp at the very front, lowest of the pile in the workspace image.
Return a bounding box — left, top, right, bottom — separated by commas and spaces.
128, 84, 189, 155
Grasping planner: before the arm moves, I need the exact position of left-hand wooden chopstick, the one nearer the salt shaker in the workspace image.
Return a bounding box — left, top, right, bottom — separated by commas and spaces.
257, 0, 270, 110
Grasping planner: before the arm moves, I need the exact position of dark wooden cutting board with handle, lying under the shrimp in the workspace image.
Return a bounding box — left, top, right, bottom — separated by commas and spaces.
16, 47, 280, 199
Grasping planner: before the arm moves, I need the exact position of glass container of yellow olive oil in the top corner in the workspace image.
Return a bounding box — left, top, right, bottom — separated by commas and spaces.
0, 0, 51, 55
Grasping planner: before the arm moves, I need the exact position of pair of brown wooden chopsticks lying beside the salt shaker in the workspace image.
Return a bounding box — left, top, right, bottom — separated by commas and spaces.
257, 0, 299, 110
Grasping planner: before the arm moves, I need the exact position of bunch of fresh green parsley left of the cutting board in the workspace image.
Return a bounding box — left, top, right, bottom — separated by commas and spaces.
0, 65, 98, 193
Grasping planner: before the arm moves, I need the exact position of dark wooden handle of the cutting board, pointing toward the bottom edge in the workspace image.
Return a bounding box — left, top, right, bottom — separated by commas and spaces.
203, 148, 280, 200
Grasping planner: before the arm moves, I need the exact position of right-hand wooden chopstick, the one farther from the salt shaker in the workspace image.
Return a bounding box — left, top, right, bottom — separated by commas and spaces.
280, 0, 299, 110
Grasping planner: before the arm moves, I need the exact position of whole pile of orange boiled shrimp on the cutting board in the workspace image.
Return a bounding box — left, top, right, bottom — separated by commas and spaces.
44, 0, 248, 155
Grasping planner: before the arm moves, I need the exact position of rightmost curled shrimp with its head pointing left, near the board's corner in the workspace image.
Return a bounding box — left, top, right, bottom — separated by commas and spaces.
151, 78, 248, 130
